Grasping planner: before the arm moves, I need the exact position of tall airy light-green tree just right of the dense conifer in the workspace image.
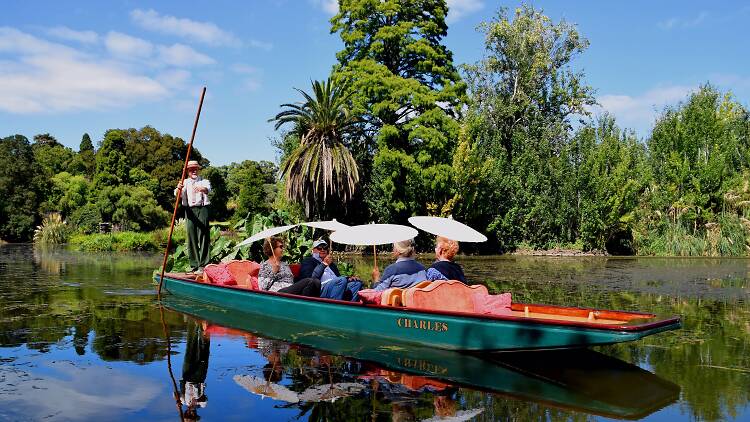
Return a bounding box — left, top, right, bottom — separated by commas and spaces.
450, 5, 594, 250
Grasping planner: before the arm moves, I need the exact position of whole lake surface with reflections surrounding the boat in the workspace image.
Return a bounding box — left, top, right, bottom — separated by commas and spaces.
0, 245, 750, 421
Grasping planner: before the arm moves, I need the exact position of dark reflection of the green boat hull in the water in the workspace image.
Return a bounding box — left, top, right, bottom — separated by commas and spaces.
165, 298, 680, 419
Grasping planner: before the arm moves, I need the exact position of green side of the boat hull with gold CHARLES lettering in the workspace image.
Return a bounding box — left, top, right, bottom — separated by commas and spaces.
157, 276, 680, 351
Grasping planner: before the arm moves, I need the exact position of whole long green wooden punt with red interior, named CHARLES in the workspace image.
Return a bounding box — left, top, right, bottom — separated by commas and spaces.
155, 273, 681, 352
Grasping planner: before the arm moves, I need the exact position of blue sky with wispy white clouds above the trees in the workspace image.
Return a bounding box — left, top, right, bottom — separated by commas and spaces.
0, 0, 750, 165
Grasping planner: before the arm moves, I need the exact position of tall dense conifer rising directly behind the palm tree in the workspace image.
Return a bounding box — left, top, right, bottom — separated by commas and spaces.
331, 0, 466, 221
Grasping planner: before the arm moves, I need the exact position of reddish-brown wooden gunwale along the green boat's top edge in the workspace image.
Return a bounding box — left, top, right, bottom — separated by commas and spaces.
162, 273, 682, 333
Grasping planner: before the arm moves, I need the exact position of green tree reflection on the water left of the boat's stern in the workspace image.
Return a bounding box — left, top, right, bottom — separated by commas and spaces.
0, 245, 178, 363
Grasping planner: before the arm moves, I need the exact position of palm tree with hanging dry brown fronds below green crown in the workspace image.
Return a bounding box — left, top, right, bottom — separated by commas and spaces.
271, 78, 360, 217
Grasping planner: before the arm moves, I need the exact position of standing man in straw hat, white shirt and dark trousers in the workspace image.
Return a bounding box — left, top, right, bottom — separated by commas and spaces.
175, 160, 211, 273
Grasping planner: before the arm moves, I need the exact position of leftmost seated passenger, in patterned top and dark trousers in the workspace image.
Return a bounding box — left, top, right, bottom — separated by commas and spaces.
258, 236, 320, 297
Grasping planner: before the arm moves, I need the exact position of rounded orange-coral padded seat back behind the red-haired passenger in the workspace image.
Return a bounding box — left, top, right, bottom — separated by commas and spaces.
401, 280, 488, 312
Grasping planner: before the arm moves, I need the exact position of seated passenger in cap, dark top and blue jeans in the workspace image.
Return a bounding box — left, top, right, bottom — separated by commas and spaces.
297, 239, 362, 301
